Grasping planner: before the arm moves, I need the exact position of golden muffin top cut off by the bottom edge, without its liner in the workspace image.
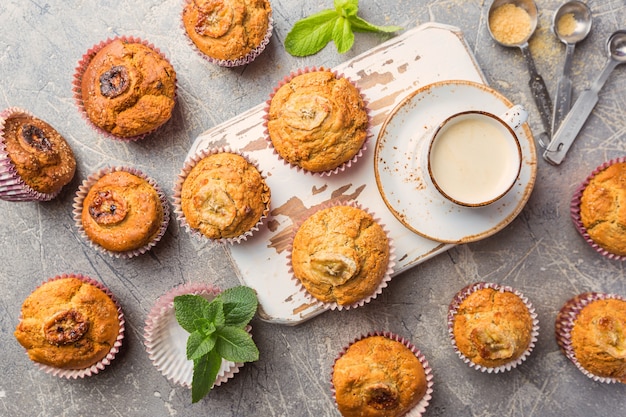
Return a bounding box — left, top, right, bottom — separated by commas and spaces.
332, 336, 427, 417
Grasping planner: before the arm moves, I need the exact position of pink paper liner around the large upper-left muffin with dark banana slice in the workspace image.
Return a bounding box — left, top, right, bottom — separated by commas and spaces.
72, 36, 178, 142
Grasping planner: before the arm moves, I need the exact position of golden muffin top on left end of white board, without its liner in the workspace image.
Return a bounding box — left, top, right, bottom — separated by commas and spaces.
181, 152, 271, 239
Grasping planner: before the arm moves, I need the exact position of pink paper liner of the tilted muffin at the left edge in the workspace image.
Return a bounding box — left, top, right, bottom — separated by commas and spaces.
0, 107, 67, 201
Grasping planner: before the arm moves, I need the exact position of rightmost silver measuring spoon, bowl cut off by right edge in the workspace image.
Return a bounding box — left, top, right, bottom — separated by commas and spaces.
543, 30, 626, 165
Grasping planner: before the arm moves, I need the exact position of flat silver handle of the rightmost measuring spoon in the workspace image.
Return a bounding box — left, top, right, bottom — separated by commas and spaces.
543, 60, 619, 165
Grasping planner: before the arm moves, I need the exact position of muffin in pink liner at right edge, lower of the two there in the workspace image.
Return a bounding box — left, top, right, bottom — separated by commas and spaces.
555, 292, 626, 384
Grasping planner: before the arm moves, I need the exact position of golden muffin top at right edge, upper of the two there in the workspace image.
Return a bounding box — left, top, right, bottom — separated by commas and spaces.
580, 162, 626, 256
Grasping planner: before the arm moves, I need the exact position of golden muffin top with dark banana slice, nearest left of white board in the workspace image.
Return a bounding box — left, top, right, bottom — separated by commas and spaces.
81, 171, 164, 252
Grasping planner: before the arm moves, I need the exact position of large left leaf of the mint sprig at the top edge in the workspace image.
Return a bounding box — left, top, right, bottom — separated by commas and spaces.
285, 10, 337, 56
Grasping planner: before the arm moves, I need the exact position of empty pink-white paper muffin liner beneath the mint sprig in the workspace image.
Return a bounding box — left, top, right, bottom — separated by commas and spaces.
144, 283, 251, 388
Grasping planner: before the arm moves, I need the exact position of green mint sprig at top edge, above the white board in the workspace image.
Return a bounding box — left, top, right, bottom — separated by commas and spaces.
285, 0, 402, 56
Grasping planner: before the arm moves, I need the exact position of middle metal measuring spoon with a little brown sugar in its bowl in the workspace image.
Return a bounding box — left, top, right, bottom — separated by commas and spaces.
551, 1, 592, 134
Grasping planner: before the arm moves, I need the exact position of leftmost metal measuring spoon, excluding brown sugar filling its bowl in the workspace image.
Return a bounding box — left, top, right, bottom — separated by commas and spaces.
487, 0, 552, 136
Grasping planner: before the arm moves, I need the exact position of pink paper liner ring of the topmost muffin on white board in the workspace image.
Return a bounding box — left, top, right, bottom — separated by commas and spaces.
263, 67, 372, 177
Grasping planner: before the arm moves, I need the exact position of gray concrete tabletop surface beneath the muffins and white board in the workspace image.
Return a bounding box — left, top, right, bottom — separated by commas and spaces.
0, 0, 626, 417
